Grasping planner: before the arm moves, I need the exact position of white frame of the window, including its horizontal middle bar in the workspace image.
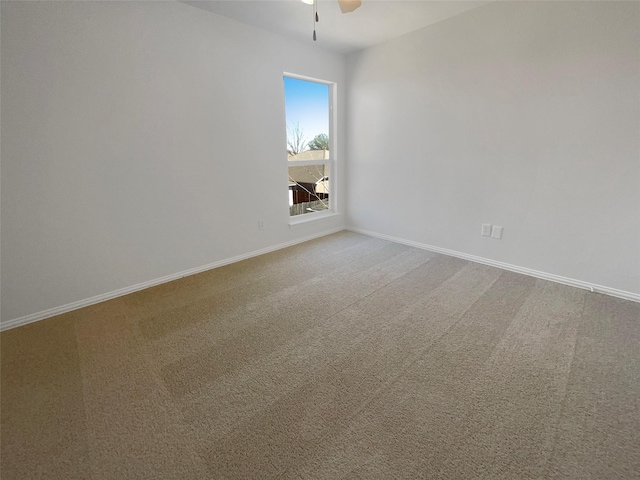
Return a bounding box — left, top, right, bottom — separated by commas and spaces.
282, 72, 338, 227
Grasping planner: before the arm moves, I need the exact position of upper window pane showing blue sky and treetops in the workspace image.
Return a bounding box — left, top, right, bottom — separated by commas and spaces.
284, 77, 329, 160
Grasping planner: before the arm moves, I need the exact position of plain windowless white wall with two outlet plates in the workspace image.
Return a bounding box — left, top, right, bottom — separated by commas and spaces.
347, 1, 640, 298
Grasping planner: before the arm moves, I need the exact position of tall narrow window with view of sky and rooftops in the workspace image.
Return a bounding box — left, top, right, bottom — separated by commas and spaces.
284, 75, 335, 218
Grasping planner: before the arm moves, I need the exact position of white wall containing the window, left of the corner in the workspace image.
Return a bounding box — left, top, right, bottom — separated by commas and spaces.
1, 2, 345, 323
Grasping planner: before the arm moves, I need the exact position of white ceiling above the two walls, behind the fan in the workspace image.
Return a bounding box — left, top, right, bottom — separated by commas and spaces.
180, 0, 492, 54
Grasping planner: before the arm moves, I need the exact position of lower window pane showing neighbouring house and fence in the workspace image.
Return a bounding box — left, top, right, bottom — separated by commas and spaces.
289, 164, 329, 216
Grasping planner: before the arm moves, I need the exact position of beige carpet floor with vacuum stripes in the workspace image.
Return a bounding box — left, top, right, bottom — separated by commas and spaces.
0, 232, 640, 480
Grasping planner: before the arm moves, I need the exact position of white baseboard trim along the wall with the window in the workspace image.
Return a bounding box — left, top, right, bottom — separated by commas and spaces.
0, 227, 344, 331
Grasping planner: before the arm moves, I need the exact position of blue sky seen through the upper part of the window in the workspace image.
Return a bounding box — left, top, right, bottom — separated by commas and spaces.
284, 77, 329, 149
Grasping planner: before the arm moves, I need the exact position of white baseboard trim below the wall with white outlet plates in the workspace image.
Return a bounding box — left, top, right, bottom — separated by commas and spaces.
346, 227, 640, 303
